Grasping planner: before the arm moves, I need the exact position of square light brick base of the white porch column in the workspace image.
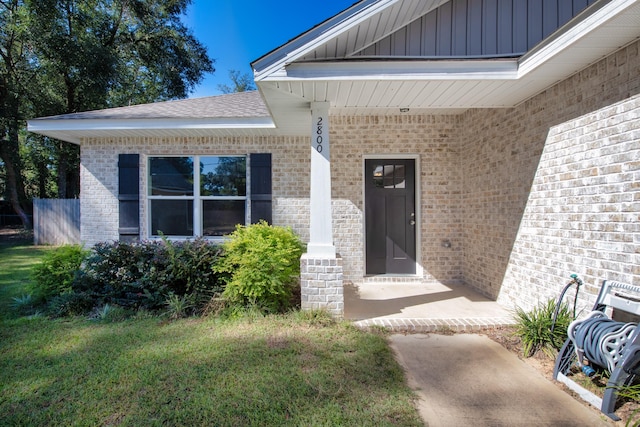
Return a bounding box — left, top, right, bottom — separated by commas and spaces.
300, 254, 344, 318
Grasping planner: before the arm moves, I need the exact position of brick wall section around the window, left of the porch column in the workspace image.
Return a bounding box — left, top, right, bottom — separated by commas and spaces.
80, 137, 309, 245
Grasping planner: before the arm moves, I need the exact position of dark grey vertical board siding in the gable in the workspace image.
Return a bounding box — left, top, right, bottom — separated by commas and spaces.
354, 0, 596, 57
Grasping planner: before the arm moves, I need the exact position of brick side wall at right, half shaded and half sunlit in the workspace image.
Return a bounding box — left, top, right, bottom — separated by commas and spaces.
461, 42, 640, 308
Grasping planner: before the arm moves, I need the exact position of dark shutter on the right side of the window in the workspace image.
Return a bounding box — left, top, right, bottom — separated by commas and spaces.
249, 153, 272, 224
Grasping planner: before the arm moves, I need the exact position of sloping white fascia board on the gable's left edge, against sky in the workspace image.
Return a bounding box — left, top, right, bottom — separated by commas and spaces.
252, 0, 401, 82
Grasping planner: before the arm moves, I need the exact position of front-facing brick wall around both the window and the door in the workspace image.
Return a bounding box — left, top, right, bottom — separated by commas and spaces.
81, 115, 462, 288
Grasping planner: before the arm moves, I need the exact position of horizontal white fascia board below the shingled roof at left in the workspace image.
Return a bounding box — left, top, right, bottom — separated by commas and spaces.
27, 117, 276, 133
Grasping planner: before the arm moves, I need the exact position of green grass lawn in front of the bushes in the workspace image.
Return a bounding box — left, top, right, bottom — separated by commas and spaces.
0, 239, 422, 426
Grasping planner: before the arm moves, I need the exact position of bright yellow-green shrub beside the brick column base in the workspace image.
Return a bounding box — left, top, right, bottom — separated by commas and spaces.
215, 221, 304, 312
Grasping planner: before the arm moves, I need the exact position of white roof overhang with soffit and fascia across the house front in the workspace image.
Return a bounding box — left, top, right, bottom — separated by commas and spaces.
28, 0, 640, 143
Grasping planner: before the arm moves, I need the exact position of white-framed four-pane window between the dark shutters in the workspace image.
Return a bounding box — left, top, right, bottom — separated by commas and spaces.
148, 156, 247, 237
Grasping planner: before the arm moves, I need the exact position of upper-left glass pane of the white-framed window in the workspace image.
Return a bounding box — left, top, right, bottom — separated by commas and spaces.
149, 157, 193, 196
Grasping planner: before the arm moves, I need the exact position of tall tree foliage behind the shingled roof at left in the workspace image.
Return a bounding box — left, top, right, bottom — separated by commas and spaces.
0, 0, 213, 227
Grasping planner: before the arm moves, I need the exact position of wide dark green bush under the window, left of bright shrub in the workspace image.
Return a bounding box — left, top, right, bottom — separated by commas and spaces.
73, 239, 223, 310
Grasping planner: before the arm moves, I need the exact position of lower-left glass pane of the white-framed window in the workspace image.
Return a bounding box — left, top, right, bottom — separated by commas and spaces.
151, 200, 193, 236
